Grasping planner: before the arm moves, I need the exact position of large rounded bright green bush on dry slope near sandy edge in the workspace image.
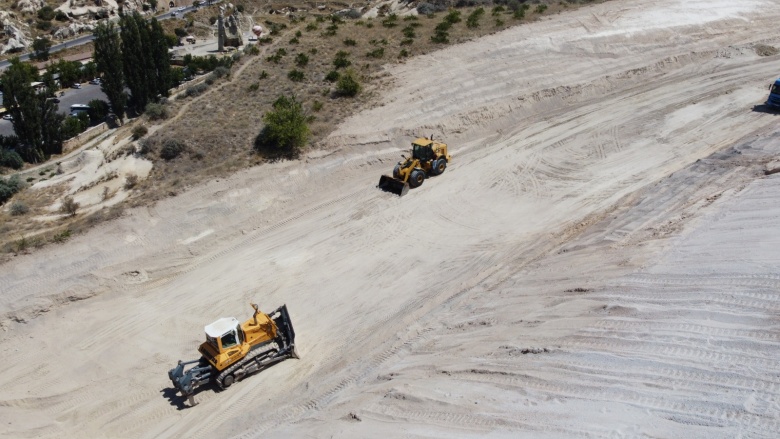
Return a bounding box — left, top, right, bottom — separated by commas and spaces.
255, 96, 310, 158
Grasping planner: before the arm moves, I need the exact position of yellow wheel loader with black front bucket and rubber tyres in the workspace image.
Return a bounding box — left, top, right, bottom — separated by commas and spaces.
377, 136, 452, 196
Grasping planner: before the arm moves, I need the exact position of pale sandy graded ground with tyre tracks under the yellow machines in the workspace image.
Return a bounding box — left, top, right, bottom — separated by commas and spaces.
0, 0, 780, 438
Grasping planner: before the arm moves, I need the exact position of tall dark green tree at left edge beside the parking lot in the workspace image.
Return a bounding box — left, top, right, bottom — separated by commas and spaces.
0, 58, 63, 163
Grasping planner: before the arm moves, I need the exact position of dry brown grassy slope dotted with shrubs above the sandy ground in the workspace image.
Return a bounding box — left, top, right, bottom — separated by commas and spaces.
0, 0, 605, 258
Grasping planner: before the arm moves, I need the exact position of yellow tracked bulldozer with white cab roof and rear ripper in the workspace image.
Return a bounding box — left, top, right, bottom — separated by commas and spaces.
168, 304, 299, 406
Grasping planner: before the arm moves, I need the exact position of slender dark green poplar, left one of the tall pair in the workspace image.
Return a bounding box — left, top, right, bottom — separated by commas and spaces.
94, 21, 127, 120
